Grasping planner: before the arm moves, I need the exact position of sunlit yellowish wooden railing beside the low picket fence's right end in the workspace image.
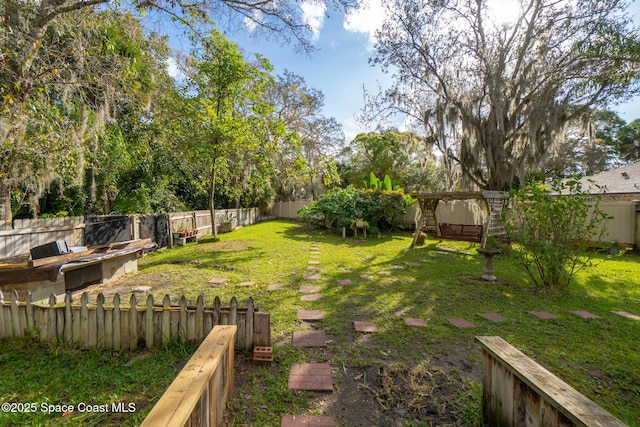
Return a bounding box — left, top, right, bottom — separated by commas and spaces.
141, 326, 237, 427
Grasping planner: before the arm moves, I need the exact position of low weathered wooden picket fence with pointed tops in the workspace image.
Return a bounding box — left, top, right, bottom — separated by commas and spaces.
0, 291, 271, 350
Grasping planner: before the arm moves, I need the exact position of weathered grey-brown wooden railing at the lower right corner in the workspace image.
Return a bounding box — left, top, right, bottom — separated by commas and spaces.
476, 337, 625, 427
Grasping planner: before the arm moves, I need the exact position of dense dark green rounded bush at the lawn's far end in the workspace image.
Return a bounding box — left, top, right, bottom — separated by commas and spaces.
298, 186, 407, 234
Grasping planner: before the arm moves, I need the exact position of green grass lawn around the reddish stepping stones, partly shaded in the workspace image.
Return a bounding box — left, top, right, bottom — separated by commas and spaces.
0, 221, 640, 426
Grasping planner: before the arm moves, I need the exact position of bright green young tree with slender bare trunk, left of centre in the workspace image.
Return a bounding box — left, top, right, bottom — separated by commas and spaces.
181, 30, 272, 235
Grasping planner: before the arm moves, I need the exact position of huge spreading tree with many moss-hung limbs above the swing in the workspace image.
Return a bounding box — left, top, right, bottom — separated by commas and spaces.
369, 0, 640, 190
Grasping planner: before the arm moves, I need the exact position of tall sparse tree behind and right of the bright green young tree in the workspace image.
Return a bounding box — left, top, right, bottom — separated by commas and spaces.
268, 70, 344, 200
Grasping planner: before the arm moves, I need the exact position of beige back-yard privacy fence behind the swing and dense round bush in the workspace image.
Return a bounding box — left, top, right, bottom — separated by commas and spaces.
271, 200, 640, 245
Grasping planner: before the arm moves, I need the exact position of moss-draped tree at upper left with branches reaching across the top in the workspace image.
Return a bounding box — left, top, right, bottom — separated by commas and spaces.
0, 0, 356, 221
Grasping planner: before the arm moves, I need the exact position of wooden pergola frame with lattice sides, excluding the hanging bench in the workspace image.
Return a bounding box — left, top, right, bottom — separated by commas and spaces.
411, 191, 508, 248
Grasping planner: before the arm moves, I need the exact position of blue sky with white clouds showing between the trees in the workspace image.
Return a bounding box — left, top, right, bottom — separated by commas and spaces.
164, 0, 640, 142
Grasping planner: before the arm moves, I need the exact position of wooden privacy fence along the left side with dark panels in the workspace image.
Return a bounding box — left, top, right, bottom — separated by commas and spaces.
0, 208, 272, 258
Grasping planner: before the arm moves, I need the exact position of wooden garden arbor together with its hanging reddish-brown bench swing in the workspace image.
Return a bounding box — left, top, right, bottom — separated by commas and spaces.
411, 191, 508, 248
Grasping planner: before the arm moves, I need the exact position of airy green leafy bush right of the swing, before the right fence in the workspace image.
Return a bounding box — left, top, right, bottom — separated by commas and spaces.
504, 179, 608, 290
